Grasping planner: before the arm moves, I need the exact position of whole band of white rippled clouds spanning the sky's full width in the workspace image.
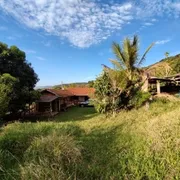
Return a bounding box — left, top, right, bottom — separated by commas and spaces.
0, 0, 180, 48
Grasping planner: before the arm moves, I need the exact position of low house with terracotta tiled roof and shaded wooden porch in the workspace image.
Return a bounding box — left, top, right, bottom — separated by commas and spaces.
36, 87, 95, 114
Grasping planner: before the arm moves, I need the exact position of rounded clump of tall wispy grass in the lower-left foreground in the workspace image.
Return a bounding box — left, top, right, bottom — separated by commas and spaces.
21, 133, 81, 180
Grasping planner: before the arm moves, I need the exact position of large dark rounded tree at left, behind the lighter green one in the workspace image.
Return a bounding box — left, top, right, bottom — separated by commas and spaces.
0, 43, 38, 112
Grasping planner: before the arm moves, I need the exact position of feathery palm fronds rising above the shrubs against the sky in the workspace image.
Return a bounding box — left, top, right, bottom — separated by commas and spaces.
111, 36, 154, 81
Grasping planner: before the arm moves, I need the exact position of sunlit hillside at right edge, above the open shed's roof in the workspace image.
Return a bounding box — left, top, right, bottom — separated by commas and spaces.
146, 54, 180, 77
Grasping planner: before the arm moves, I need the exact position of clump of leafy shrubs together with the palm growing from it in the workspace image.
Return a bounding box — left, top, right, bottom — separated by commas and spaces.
94, 36, 154, 114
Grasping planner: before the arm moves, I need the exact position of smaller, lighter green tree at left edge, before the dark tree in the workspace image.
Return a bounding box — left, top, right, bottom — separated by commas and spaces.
0, 74, 17, 117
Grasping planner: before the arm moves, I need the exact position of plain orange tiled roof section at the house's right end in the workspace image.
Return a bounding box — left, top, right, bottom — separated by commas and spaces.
67, 87, 95, 96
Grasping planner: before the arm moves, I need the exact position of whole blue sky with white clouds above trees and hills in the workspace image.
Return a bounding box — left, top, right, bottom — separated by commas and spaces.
0, 0, 180, 86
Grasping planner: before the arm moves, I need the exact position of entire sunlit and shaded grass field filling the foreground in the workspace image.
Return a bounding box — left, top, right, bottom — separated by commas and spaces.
0, 101, 180, 180
